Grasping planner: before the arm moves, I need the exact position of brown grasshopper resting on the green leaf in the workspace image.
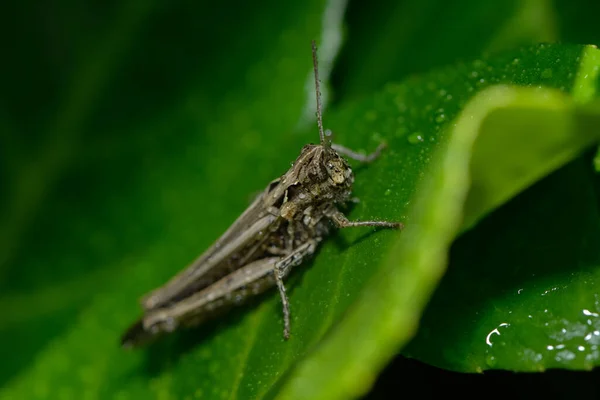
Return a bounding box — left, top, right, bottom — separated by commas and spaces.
122, 41, 402, 347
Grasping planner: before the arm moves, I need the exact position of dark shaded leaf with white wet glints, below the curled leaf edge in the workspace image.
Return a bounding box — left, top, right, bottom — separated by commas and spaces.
406, 157, 600, 372
